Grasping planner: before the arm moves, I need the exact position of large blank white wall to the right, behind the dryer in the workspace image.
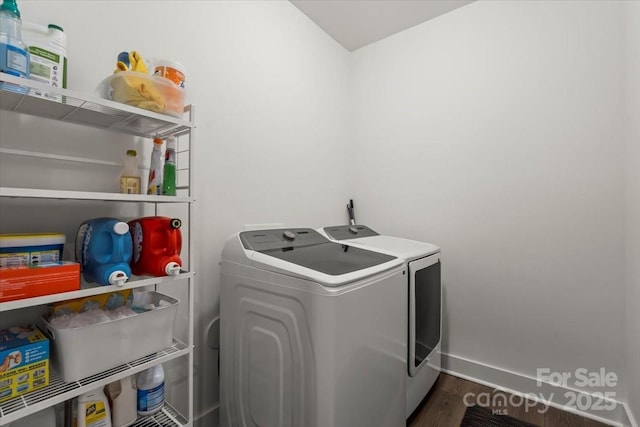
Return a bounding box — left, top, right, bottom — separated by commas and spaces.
350, 1, 637, 404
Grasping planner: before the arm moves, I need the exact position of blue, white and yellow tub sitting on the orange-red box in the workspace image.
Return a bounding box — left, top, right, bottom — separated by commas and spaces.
0, 233, 66, 267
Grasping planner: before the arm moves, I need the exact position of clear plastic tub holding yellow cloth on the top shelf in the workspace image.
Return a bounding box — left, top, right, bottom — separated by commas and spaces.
97, 71, 184, 117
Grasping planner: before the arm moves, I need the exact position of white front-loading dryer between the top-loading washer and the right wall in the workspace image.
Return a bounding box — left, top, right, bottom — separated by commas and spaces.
319, 225, 442, 418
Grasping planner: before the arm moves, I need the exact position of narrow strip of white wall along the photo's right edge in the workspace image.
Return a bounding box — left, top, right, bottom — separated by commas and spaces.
625, 2, 640, 422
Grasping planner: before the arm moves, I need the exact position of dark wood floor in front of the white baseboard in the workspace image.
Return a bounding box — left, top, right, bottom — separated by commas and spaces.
407, 374, 606, 427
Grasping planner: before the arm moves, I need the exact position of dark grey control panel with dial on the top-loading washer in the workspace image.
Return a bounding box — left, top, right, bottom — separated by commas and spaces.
240, 228, 329, 252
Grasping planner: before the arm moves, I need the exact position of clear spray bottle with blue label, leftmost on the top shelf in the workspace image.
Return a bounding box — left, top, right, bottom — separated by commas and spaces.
0, 0, 29, 84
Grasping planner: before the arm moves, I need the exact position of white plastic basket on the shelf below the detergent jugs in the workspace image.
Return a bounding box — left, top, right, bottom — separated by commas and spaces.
42, 291, 180, 382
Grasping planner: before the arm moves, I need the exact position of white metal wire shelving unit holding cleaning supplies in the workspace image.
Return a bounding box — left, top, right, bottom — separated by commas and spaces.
0, 73, 195, 427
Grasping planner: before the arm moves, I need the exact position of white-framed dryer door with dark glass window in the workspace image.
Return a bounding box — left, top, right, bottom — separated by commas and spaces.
407, 253, 442, 376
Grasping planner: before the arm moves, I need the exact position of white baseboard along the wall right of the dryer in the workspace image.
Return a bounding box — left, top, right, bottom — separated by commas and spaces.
442, 353, 638, 427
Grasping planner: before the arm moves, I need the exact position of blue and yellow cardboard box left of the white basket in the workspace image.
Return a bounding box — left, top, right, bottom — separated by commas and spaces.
0, 325, 49, 402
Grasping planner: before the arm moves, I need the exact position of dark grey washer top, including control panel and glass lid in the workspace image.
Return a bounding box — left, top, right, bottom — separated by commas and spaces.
240, 228, 397, 276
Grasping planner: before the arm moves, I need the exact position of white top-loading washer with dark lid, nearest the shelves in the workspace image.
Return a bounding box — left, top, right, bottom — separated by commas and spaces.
220, 228, 407, 427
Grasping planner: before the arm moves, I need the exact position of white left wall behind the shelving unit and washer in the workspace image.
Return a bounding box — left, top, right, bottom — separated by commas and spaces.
2, 0, 350, 426
